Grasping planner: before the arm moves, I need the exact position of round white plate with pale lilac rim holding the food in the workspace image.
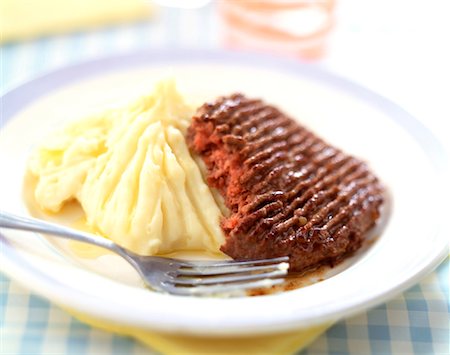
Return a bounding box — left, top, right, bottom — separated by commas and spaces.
0, 51, 447, 335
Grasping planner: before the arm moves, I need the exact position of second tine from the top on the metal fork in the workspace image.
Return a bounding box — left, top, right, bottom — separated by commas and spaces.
177, 262, 289, 276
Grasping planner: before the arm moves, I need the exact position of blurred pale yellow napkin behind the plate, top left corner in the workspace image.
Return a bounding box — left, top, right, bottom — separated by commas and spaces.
0, 0, 154, 42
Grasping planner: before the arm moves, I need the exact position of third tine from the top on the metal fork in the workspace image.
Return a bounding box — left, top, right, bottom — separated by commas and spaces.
173, 269, 287, 286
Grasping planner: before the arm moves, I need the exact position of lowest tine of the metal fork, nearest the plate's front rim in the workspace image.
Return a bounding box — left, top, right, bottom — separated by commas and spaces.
161, 279, 284, 296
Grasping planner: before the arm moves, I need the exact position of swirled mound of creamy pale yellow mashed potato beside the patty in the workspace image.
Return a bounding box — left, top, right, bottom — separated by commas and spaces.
29, 80, 224, 255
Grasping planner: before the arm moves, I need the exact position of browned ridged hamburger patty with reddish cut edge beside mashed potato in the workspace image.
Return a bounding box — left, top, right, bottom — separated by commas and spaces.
187, 94, 383, 271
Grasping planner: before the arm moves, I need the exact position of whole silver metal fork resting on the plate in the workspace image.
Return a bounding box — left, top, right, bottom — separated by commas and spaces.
0, 212, 289, 296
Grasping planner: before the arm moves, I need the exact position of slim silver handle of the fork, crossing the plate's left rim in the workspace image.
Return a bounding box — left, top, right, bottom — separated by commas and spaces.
0, 211, 124, 256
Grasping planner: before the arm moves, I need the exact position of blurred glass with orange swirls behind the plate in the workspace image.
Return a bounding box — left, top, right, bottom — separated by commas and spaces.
217, 0, 335, 59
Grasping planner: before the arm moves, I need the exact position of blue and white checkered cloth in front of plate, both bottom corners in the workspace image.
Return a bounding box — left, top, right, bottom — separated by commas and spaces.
0, 260, 449, 355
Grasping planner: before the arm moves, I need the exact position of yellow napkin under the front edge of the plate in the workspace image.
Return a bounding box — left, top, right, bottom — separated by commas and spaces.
67, 310, 331, 355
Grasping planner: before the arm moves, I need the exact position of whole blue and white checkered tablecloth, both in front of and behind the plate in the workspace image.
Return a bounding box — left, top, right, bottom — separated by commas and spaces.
0, 7, 449, 355
